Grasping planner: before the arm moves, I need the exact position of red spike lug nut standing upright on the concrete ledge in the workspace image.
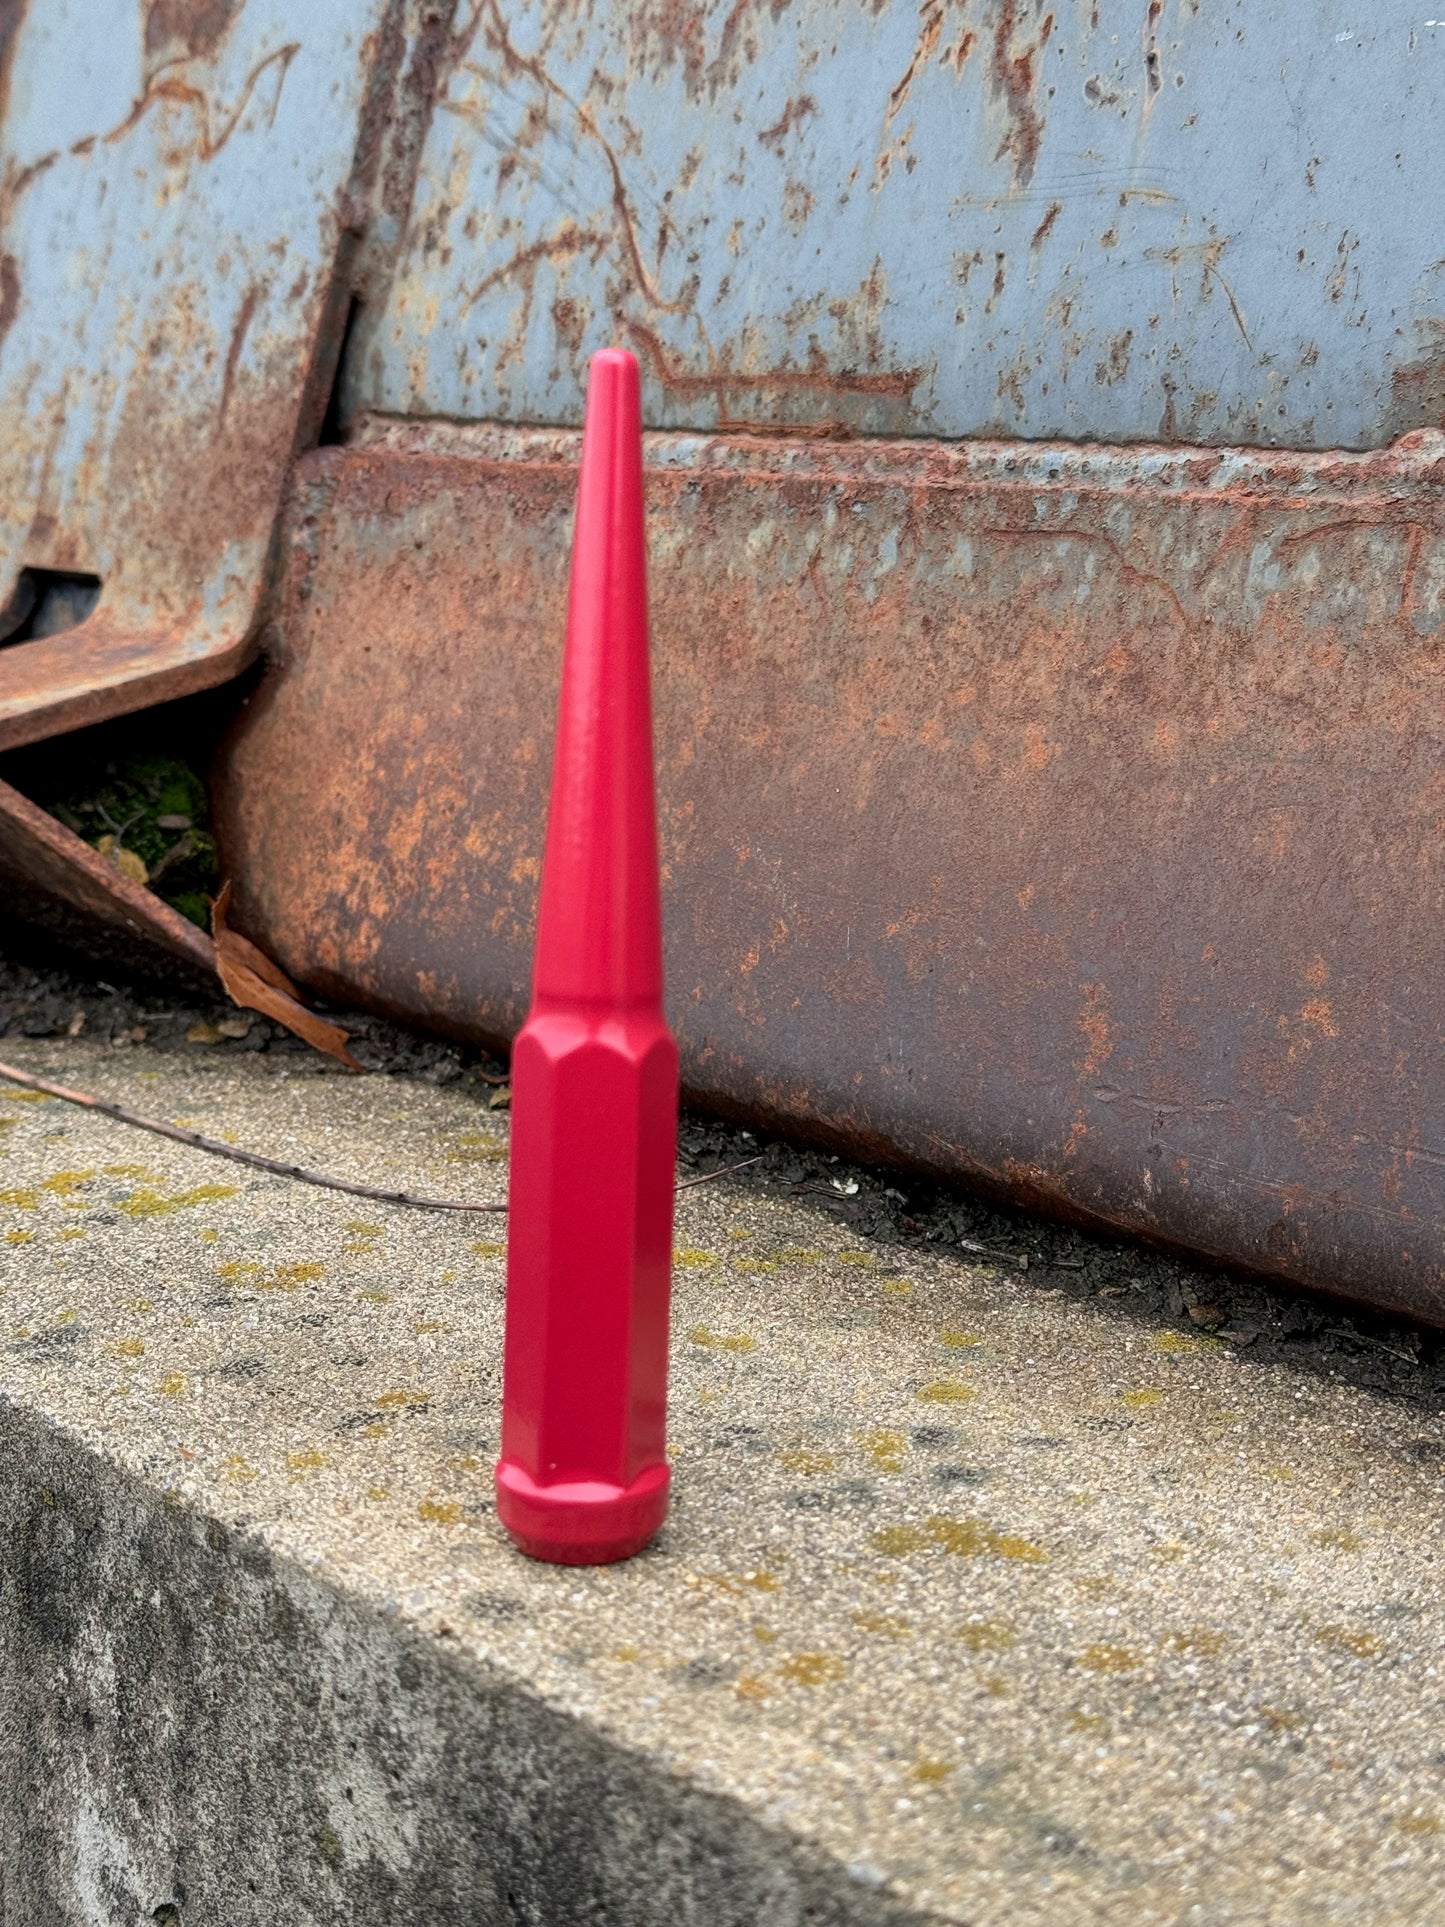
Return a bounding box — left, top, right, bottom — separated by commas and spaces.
497, 349, 678, 1565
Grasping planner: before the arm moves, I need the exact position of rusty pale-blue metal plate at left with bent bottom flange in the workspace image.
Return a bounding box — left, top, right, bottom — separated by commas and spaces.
0, 0, 410, 746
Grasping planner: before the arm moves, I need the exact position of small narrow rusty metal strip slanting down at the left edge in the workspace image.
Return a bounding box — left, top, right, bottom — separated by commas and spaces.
0, 782, 216, 989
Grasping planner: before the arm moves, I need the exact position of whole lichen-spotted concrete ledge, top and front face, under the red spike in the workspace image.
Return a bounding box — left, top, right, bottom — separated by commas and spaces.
0, 1039, 1445, 1927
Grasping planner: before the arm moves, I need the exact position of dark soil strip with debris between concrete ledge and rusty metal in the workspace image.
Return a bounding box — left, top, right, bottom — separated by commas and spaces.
0, 940, 1445, 1425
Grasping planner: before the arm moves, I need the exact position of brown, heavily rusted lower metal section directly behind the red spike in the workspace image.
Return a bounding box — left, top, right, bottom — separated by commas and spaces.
218, 424, 1445, 1322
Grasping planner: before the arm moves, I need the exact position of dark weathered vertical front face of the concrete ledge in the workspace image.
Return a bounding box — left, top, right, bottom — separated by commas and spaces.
0, 1407, 904, 1927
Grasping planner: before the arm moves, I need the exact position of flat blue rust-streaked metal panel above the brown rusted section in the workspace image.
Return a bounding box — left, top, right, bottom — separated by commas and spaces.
349, 0, 1445, 449
